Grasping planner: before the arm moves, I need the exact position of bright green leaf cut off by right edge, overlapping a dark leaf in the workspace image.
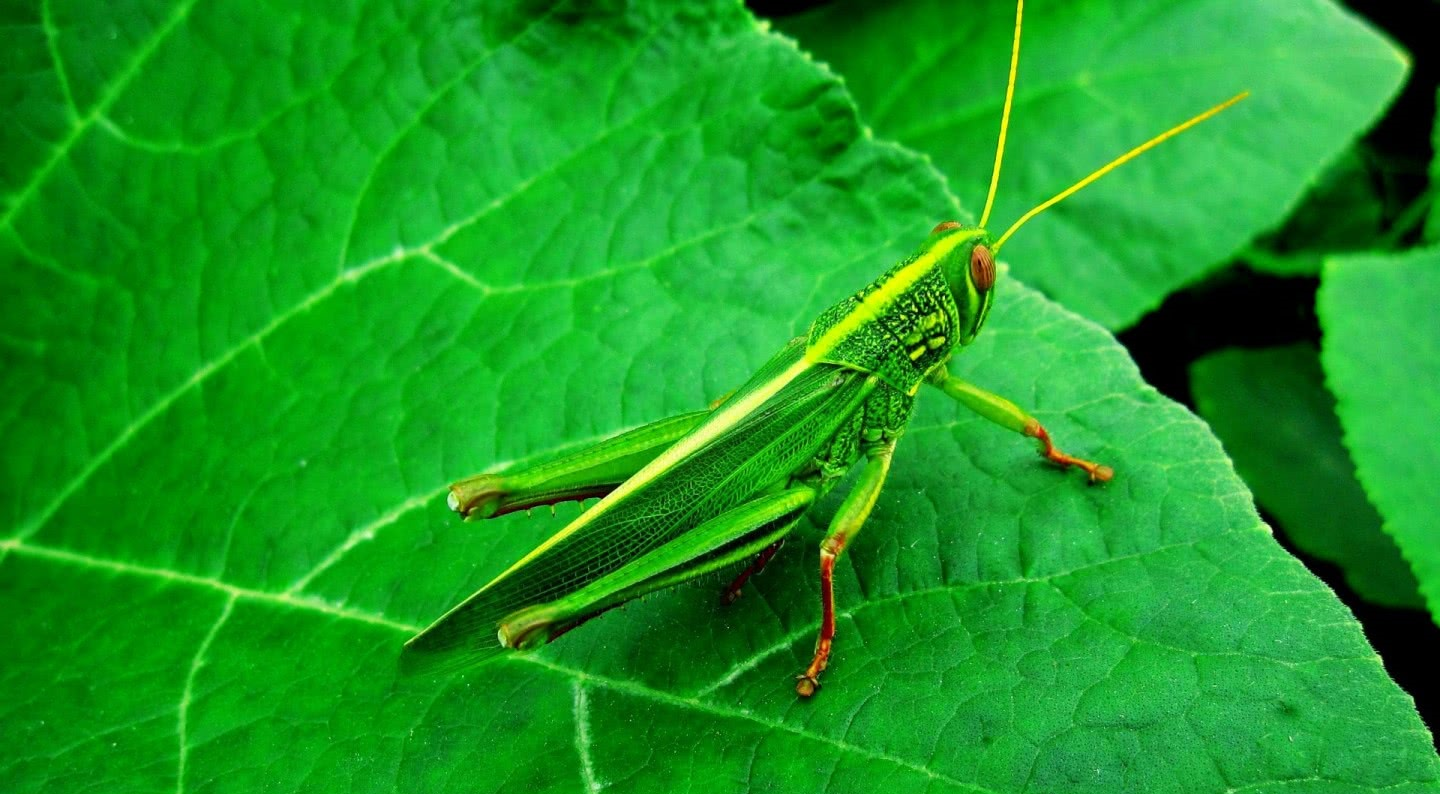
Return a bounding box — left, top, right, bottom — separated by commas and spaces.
1318, 248, 1440, 623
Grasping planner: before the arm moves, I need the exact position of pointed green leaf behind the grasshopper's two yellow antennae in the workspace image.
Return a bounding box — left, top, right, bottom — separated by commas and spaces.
782, 0, 1407, 327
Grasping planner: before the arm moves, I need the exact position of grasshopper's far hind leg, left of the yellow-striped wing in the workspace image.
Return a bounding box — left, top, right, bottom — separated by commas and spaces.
449, 411, 710, 519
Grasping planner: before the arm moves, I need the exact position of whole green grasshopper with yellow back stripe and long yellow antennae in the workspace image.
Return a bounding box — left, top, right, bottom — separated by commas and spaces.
405, 1, 1246, 697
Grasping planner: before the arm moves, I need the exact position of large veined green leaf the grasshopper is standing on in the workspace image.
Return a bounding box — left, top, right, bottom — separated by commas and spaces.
0, 3, 1440, 793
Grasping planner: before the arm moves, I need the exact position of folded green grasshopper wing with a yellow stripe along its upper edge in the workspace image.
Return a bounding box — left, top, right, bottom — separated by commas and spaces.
405, 340, 877, 672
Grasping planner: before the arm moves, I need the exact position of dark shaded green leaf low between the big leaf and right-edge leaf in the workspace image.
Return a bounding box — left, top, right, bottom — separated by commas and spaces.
1191, 344, 1423, 607
